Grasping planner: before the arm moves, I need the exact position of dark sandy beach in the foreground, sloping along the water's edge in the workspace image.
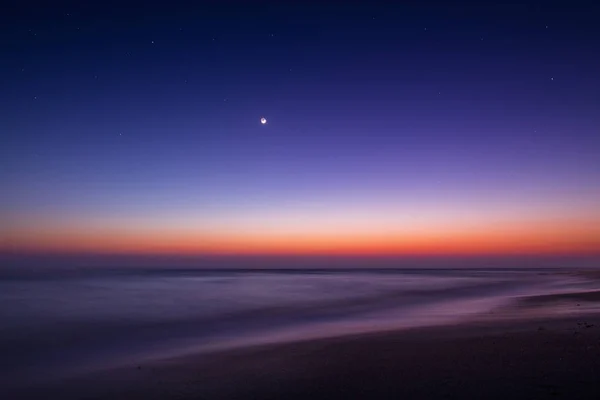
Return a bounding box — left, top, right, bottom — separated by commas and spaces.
3, 316, 600, 400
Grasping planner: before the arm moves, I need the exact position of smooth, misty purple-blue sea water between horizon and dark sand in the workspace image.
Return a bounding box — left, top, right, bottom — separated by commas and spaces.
0, 269, 599, 383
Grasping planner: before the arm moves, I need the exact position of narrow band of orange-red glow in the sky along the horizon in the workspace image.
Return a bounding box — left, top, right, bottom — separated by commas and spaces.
0, 219, 600, 256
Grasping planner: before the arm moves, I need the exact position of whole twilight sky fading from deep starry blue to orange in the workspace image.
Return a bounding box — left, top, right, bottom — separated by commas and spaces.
0, 1, 600, 255
